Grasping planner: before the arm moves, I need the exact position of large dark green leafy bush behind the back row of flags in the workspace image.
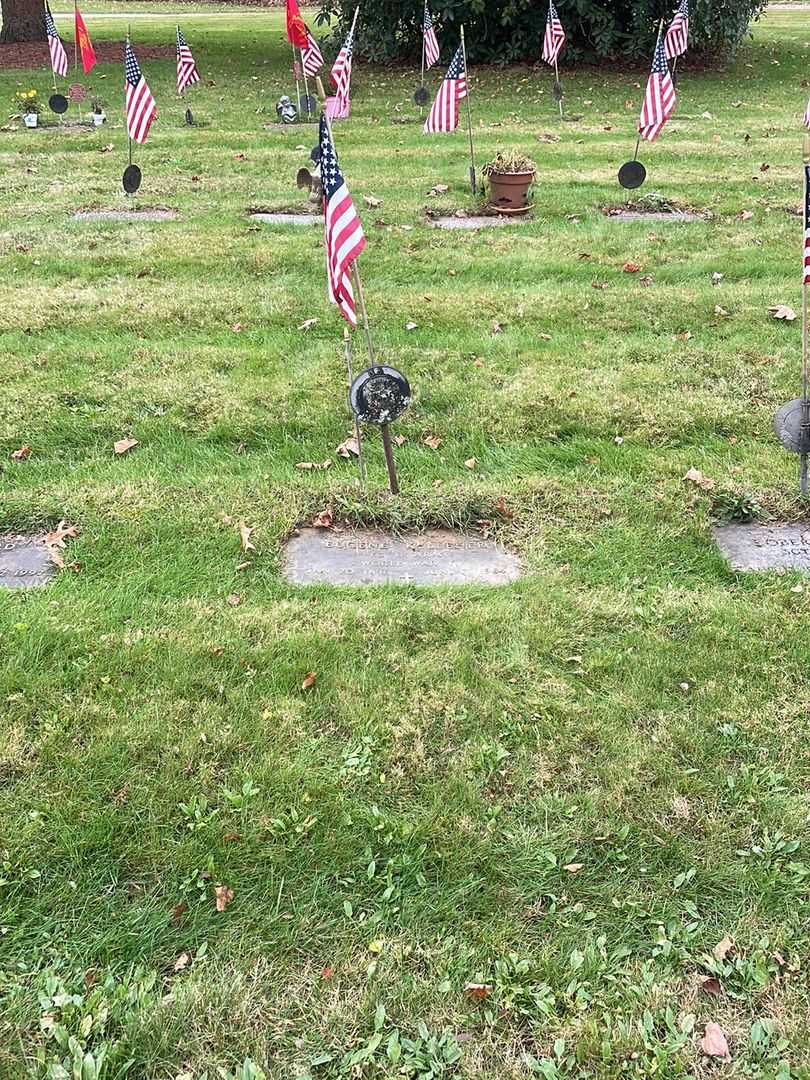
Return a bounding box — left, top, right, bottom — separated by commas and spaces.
318, 0, 767, 64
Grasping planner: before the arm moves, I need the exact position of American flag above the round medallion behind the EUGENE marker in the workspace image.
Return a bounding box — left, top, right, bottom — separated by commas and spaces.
321, 116, 366, 326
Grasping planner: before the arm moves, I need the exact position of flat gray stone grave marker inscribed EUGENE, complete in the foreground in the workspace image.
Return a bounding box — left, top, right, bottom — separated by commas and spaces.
284, 529, 523, 585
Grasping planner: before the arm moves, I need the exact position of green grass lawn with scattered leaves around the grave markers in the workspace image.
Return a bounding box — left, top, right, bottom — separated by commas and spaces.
0, 4, 810, 1080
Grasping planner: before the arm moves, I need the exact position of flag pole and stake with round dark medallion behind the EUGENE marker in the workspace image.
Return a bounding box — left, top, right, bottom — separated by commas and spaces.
316, 76, 410, 495
